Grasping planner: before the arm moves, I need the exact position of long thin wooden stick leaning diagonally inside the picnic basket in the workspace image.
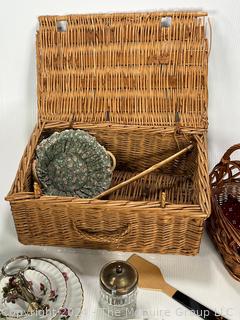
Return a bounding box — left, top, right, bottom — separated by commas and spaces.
94, 144, 193, 199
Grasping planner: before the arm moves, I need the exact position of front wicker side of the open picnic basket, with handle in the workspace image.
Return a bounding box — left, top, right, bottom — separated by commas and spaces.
8, 197, 205, 255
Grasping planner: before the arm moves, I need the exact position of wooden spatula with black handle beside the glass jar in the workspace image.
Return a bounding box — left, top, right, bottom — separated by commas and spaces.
128, 254, 227, 320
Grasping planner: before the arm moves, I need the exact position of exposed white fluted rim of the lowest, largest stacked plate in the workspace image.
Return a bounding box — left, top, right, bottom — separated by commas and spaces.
42, 259, 84, 320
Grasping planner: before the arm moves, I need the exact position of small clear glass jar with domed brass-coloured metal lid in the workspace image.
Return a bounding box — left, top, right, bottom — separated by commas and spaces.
100, 261, 138, 319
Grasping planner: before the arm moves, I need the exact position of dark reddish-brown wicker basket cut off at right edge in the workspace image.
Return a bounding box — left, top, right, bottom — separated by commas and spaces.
207, 144, 240, 281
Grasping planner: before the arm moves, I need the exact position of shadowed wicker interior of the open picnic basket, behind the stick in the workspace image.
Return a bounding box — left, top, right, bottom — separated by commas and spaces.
25, 127, 200, 204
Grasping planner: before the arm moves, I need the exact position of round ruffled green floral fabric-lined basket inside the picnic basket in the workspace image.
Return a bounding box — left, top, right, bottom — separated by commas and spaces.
36, 129, 115, 198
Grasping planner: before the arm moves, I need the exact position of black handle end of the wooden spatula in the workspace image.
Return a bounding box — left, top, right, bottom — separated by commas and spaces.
172, 291, 227, 320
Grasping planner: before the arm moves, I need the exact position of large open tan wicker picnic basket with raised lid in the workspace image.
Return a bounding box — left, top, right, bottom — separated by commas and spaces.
7, 12, 210, 255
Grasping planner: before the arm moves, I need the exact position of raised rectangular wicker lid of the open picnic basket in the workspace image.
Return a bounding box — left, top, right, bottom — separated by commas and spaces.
37, 12, 208, 129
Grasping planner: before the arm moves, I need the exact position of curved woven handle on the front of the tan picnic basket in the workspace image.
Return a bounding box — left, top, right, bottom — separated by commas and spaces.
73, 221, 131, 243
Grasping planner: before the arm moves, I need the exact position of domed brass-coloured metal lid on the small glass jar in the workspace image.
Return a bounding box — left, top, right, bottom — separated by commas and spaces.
100, 261, 138, 296
